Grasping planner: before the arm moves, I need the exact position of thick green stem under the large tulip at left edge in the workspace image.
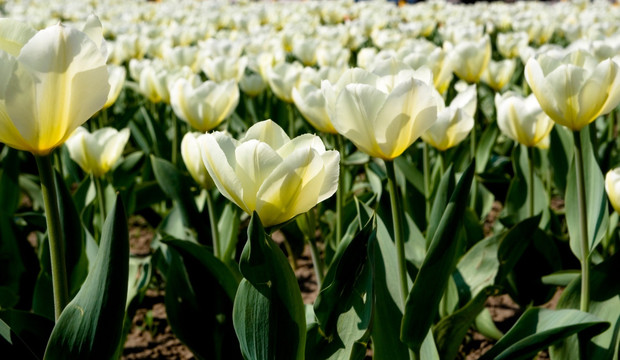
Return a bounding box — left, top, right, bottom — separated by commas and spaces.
35, 155, 69, 320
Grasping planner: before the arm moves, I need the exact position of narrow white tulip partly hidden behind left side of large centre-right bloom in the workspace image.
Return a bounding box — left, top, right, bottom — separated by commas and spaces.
293, 82, 338, 134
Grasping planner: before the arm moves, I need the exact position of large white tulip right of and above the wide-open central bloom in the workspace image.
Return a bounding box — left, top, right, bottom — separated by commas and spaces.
330, 61, 440, 160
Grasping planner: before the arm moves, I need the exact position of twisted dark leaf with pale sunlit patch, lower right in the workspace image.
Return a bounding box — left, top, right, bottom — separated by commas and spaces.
433, 215, 540, 359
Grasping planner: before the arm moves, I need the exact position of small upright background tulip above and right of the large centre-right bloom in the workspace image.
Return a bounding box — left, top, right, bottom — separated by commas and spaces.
448, 36, 491, 84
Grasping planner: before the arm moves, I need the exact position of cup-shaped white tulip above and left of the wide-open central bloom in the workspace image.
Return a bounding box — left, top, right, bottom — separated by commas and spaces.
170, 79, 239, 132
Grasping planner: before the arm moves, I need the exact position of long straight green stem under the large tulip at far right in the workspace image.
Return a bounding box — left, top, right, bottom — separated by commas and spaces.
573, 131, 590, 312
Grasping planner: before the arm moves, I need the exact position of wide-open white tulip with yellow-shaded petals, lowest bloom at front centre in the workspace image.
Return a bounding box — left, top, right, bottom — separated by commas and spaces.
198, 120, 340, 226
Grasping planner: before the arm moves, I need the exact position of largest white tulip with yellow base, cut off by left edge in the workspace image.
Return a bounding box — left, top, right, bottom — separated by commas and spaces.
0, 16, 110, 155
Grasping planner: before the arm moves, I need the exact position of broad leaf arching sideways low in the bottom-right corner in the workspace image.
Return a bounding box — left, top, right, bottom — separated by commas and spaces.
480, 308, 609, 360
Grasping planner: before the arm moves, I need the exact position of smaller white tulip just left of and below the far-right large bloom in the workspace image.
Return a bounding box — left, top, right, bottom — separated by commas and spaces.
495, 91, 553, 148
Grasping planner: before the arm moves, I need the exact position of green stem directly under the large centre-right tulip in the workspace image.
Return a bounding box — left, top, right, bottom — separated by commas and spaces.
385, 161, 409, 309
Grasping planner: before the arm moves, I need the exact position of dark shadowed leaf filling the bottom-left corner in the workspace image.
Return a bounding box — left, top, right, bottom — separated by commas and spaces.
0, 310, 54, 360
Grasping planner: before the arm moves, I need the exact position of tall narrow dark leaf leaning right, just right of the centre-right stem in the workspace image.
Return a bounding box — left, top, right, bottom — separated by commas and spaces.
400, 162, 476, 352
